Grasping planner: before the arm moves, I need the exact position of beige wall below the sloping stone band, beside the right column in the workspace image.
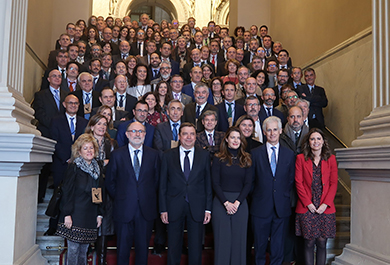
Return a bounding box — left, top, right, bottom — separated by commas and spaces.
310, 31, 372, 146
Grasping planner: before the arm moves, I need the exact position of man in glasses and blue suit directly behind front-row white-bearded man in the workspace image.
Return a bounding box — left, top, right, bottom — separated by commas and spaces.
116, 100, 154, 147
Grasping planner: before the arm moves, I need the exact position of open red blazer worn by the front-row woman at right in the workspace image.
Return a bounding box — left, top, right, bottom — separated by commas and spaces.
295, 154, 338, 214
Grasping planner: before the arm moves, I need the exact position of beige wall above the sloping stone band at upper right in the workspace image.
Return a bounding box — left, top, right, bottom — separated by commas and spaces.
269, 0, 372, 65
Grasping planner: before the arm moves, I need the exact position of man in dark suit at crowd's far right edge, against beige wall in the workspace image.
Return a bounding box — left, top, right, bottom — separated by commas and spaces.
297, 68, 328, 128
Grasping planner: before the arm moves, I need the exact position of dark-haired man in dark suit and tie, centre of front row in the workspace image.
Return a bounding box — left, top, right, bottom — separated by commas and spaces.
159, 123, 212, 265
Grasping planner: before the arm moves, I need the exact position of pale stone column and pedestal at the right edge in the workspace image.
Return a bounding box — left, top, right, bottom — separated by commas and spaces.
332, 0, 390, 265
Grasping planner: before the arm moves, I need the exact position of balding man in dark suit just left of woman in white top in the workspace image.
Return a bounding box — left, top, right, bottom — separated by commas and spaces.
114, 75, 137, 116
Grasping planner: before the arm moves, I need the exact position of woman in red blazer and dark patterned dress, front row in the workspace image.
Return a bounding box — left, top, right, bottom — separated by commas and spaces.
295, 128, 338, 265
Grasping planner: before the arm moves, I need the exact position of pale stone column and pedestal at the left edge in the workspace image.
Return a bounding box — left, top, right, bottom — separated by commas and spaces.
0, 0, 55, 265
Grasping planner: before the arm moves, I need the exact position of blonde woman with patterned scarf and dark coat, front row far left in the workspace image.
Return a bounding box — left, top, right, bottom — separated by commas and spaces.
56, 134, 103, 265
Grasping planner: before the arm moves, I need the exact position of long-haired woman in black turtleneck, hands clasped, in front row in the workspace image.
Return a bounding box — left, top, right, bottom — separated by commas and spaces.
212, 127, 252, 265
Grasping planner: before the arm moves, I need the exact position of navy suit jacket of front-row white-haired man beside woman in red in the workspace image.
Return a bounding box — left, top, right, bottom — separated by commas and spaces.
250, 144, 295, 218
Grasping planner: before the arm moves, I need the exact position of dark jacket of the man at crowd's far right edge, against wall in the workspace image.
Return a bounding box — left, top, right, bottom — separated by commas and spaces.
296, 84, 328, 128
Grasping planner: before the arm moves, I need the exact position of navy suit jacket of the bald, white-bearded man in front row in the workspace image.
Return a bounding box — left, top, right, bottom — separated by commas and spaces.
105, 145, 160, 223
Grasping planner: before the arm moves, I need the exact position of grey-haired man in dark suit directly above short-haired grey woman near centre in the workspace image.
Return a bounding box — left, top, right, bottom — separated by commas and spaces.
183, 82, 218, 132
